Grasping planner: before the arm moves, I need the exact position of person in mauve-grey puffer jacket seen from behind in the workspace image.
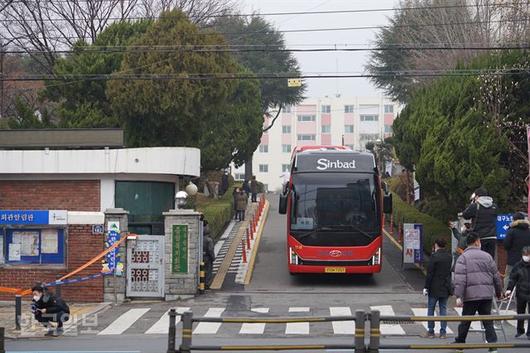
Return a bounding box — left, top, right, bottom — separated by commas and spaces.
454, 232, 503, 353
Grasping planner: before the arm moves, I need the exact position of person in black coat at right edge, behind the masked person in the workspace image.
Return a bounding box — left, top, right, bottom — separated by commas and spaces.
504, 212, 530, 288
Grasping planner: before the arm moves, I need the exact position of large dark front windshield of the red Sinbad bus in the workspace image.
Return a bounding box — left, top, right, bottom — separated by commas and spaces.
290, 173, 380, 245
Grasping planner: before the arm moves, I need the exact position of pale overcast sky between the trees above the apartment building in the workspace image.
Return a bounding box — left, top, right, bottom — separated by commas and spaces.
239, 0, 397, 98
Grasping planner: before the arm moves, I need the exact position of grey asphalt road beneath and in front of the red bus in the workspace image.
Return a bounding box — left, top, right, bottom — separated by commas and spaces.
6, 195, 516, 353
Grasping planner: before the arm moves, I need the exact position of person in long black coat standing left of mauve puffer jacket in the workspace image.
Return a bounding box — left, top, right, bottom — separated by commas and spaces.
423, 239, 453, 338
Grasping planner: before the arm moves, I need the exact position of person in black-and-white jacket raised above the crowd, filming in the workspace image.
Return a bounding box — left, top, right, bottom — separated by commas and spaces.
462, 188, 497, 259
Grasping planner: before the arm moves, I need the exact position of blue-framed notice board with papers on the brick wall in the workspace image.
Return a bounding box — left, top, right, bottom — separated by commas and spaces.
1, 228, 64, 265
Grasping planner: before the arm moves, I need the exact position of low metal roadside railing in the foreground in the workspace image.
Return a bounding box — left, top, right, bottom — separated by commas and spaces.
167, 309, 530, 353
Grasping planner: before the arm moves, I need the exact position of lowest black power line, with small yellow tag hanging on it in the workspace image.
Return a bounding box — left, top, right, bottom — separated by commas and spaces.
0, 68, 530, 81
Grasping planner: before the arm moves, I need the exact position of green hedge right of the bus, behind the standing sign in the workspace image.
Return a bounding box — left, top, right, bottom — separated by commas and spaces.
392, 193, 451, 254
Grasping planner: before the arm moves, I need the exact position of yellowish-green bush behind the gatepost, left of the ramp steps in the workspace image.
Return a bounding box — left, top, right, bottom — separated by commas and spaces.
197, 189, 234, 239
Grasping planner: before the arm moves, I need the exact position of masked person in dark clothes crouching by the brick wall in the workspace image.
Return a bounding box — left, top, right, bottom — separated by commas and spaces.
31, 284, 70, 336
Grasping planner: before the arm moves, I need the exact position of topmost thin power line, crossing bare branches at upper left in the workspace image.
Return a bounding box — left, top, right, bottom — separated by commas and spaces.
0, 1, 530, 22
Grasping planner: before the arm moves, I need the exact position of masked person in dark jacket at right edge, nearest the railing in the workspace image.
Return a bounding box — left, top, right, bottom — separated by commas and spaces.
506, 246, 530, 340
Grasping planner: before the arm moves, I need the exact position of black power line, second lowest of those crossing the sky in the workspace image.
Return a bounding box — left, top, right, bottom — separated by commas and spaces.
4, 44, 530, 54
